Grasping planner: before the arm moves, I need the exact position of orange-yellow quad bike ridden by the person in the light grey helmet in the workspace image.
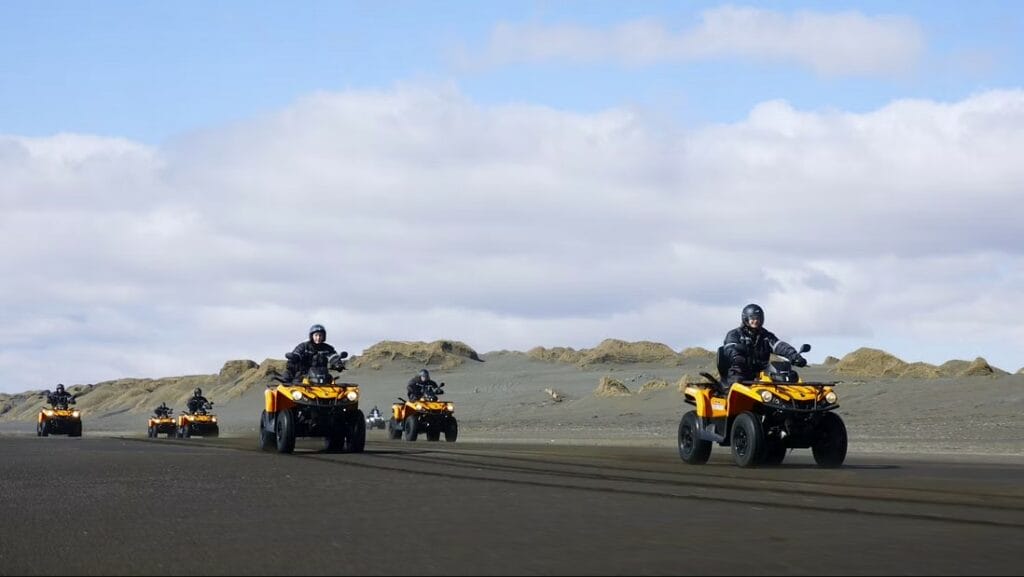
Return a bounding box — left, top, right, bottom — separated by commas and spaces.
259, 352, 367, 453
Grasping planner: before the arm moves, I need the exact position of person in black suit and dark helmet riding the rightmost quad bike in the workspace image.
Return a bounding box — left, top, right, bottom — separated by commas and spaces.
723, 304, 807, 386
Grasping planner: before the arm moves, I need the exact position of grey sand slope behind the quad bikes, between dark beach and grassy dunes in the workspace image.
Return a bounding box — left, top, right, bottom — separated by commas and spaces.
0, 353, 1024, 456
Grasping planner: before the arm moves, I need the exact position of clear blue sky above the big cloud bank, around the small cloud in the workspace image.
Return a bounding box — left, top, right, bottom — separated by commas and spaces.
0, 1, 1024, 143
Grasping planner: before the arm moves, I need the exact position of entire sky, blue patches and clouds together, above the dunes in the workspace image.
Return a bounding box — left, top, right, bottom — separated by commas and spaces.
0, 0, 1024, 393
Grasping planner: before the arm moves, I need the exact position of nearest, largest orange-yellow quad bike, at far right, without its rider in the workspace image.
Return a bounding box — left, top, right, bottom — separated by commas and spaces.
679, 344, 847, 467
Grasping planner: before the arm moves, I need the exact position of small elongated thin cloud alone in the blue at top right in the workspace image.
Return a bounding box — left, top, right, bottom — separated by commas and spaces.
475, 6, 925, 75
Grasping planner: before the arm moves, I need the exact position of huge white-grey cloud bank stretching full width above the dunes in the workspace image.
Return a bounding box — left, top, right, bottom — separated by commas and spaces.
0, 86, 1024, 390
